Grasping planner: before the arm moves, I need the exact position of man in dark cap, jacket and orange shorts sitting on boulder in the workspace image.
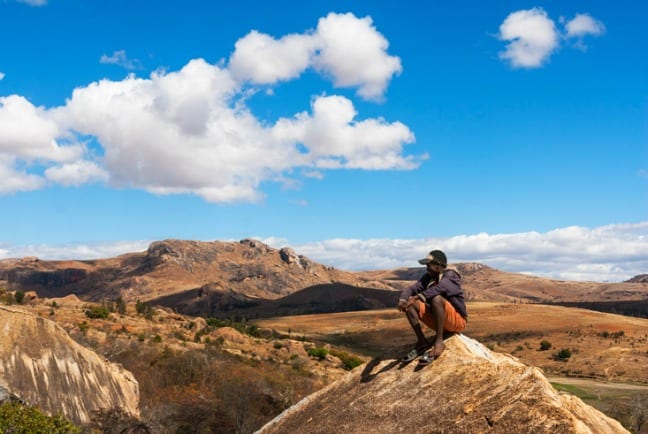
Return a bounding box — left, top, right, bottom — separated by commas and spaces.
398, 250, 468, 365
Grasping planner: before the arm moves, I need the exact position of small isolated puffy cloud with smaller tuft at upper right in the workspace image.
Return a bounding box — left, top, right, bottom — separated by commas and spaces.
498, 8, 605, 68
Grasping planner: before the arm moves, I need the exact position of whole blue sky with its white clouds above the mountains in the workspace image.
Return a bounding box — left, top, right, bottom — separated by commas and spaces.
0, 0, 648, 281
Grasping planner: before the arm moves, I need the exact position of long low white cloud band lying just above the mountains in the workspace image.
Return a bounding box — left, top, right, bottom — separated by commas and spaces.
0, 221, 648, 282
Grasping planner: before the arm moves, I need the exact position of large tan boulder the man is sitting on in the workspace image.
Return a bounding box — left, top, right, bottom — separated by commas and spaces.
259, 335, 627, 434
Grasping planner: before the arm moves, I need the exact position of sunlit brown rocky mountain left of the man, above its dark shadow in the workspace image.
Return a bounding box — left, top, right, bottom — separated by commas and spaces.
0, 239, 387, 301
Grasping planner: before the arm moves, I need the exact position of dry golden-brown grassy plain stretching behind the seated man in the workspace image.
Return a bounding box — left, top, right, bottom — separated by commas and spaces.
255, 302, 648, 384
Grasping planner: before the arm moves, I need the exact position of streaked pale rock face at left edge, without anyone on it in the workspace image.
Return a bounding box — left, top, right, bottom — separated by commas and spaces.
0, 306, 139, 424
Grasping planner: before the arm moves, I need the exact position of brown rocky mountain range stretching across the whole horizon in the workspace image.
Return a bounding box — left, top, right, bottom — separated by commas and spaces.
0, 239, 648, 318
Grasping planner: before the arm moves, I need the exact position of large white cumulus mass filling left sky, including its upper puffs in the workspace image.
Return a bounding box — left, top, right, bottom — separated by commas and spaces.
0, 13, 420, 203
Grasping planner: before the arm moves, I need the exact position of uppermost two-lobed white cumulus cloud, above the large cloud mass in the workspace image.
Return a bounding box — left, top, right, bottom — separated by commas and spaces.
229, 13, 402, 100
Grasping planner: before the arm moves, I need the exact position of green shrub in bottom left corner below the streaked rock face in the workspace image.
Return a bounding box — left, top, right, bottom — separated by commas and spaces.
0, 402, 81, 434
